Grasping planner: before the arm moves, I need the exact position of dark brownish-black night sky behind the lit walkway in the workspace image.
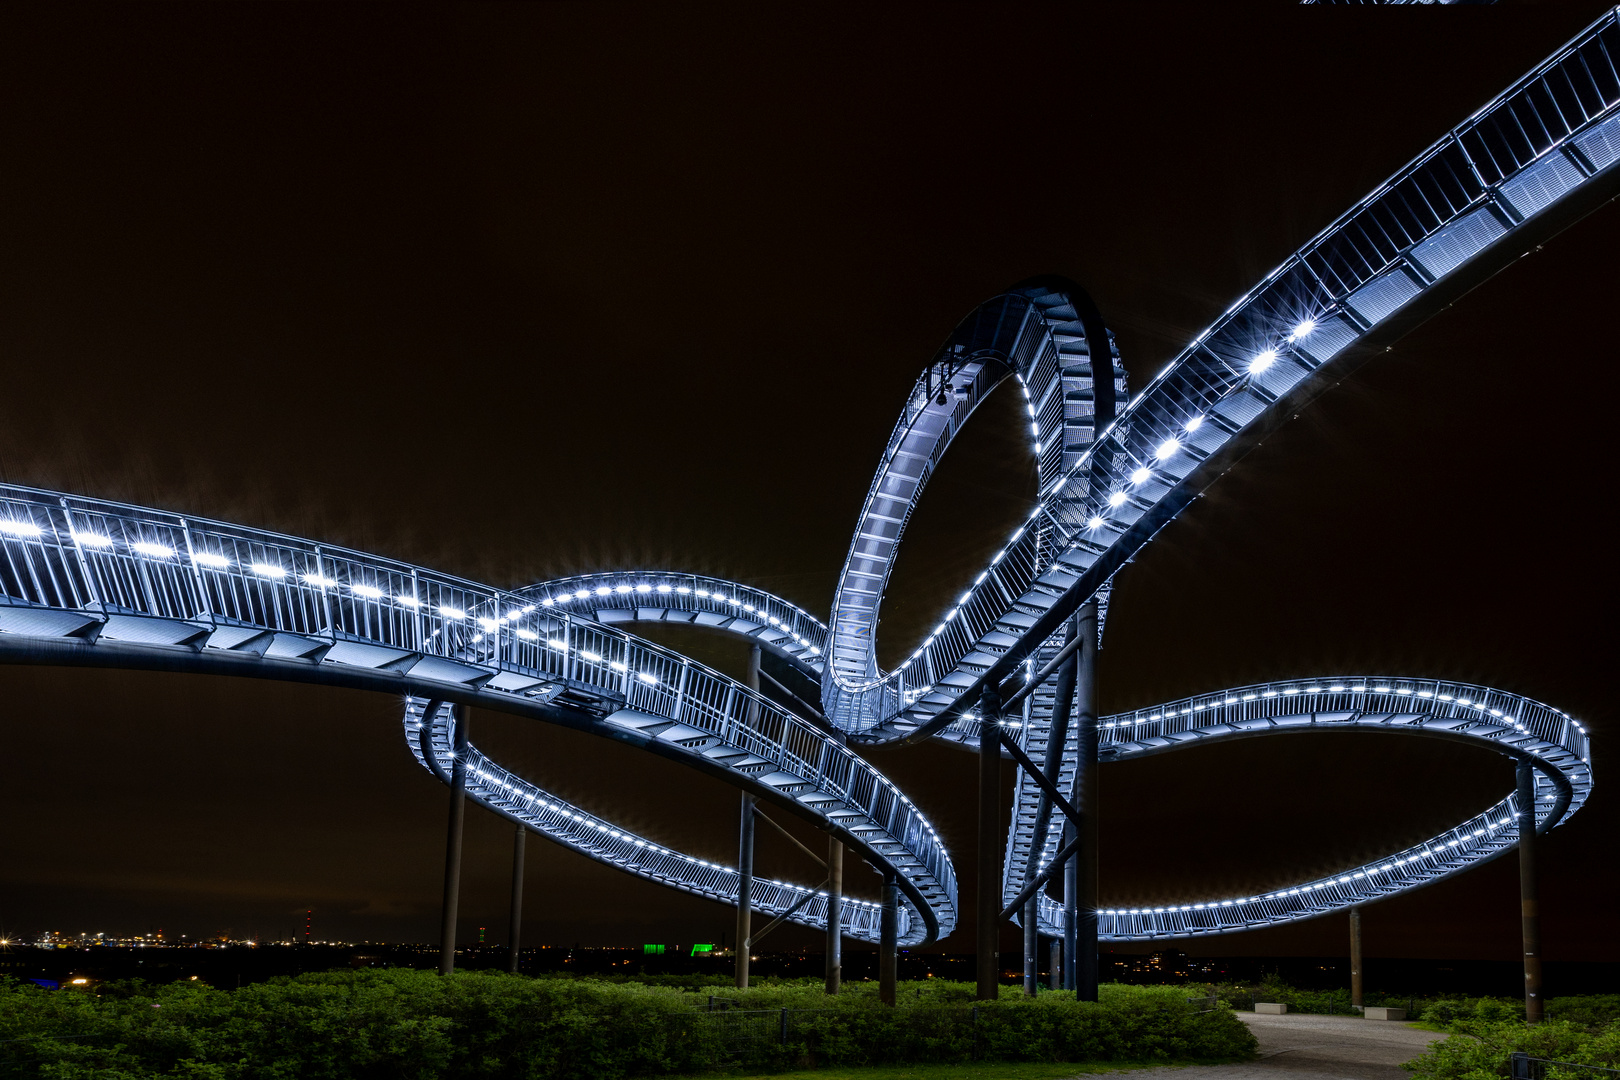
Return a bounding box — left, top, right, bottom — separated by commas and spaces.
0, 3, 1620, 960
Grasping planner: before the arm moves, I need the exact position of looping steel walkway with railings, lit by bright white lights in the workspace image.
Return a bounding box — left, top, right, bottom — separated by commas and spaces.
0, 11, 1620, 946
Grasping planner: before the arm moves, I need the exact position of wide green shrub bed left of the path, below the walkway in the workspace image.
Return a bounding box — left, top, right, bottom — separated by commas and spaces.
0, 968, 1256, 1080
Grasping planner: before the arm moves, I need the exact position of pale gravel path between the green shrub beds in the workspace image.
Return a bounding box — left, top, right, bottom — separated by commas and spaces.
1129, 1012, 1445, 1080
